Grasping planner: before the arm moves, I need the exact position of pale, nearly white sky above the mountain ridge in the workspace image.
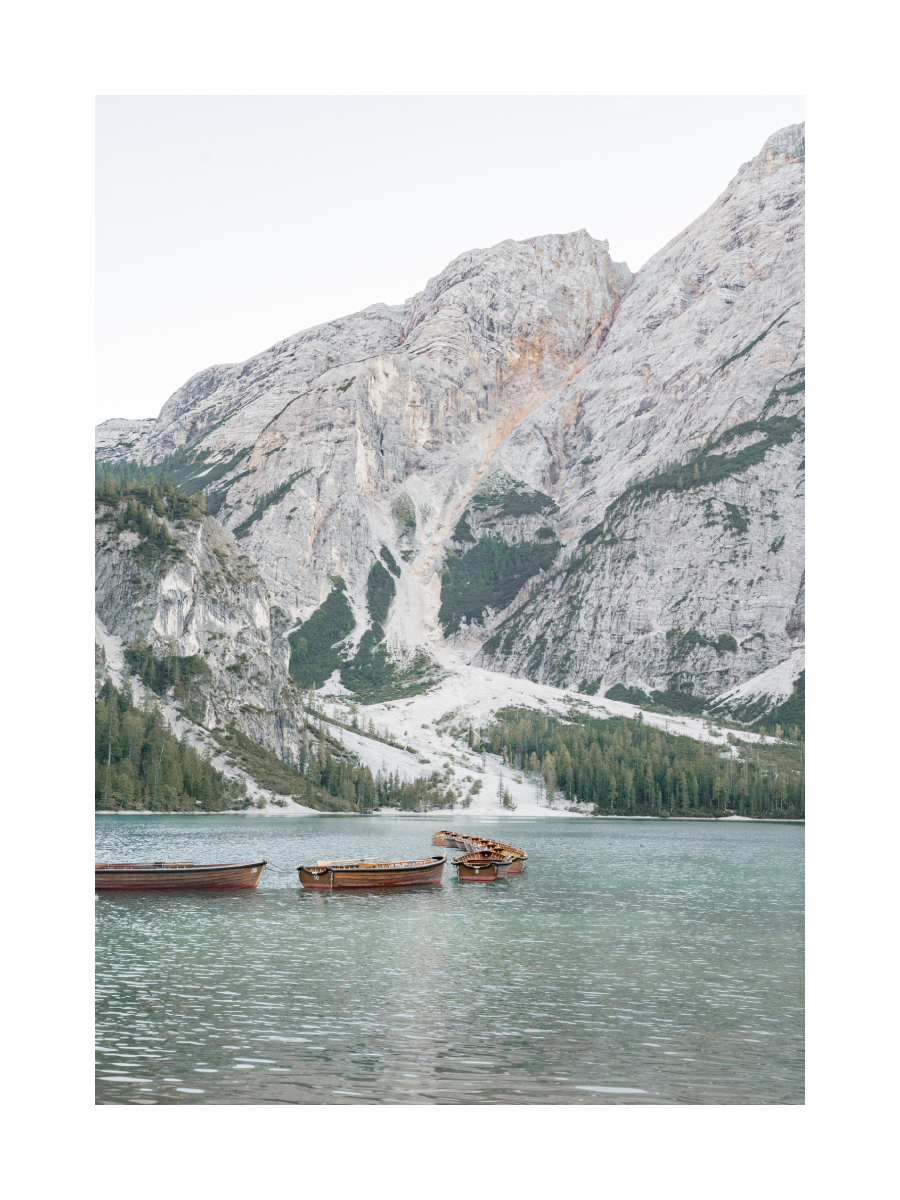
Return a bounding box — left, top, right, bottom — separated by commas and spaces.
97, 96, 804, 421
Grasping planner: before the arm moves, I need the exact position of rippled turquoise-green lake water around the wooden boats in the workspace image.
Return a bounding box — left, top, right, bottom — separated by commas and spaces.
96, 814, 804, 1104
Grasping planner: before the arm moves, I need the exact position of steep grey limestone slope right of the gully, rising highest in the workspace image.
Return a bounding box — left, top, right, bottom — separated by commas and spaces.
481, 119, 804, 695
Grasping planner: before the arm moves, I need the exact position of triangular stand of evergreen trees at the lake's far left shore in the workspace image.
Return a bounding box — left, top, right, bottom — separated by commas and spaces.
95, 683, 248, 812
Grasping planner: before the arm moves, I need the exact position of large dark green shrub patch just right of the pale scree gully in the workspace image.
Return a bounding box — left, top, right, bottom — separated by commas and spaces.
438, 538, 560, 634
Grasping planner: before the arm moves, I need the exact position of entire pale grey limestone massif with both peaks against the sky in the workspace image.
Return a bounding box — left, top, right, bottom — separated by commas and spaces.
97, 126, 804, 707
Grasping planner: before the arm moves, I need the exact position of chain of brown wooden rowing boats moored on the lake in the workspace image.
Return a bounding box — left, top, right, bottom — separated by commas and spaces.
94, 829, 528, 892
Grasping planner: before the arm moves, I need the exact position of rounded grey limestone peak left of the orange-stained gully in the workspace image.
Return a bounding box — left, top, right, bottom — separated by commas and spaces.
97, 232, 631, 646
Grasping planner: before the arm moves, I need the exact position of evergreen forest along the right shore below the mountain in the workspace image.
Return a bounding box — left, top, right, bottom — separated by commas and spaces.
481, 708, 804, 817
